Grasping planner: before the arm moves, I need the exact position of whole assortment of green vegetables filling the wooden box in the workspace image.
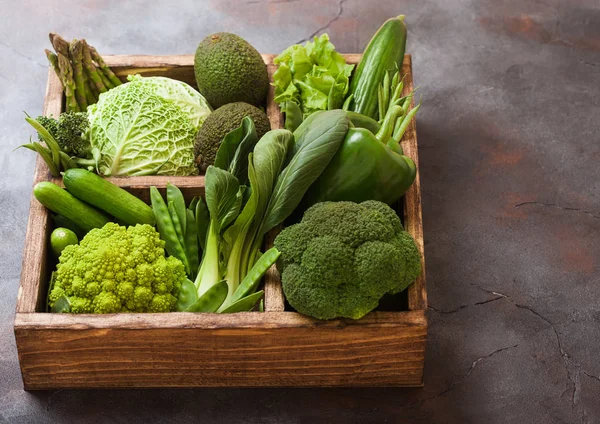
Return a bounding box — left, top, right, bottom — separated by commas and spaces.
28, 16, 421, 319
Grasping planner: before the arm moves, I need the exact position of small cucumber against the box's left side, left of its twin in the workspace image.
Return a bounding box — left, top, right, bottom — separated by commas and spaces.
33, 181, 110, 232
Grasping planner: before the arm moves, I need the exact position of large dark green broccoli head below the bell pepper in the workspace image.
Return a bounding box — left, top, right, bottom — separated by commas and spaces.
275, 200, 421, 319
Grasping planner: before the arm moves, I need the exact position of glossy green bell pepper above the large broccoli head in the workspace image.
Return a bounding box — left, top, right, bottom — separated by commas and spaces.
303, 128, 417, 207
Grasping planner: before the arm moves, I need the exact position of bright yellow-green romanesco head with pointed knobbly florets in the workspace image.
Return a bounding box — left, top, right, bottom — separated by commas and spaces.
48, 222, 186, 314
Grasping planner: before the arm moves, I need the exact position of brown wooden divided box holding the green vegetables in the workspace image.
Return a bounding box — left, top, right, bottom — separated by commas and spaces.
14, 54, 427, 390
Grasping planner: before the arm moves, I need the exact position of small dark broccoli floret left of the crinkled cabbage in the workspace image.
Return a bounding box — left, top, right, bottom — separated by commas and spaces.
36, 112, 91, 158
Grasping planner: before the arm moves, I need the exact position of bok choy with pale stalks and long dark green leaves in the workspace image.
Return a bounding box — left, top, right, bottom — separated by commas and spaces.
186, 110, 349, 309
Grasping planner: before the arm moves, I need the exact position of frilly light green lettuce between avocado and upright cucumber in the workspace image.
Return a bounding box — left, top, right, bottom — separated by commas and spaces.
273, 34, 354, 118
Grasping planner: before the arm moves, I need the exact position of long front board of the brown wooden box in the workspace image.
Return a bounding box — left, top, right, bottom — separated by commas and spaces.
15, 312, 426, 390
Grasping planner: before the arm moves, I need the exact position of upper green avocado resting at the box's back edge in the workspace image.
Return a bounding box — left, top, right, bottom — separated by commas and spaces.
194, 32, 269, 109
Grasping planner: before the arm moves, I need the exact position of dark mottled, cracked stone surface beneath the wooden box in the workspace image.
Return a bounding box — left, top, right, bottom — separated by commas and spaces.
0, 0, 600, 423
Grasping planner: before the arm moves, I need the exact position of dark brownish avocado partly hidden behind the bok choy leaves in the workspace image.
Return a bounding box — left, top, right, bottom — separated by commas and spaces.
194, 102, 271, 174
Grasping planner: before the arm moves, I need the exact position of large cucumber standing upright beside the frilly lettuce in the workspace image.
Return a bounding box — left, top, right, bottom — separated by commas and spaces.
348, 15, 406, 120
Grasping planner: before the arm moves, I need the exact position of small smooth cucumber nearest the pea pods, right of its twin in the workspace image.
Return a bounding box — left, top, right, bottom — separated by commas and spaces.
63, 168, 156, 225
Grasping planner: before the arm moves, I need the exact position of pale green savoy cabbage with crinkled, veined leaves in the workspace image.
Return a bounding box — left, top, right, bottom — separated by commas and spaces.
87, 77, 198, 176
